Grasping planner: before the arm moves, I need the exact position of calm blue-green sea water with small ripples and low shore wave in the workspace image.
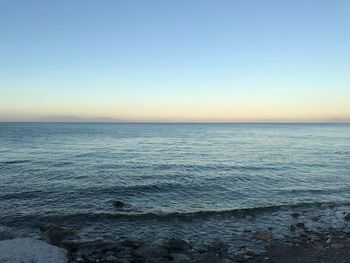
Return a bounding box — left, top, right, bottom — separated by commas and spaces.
0, 123, 350, 248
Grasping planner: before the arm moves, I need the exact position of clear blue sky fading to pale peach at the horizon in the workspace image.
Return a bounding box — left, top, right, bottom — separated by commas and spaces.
0, 0, 350, 122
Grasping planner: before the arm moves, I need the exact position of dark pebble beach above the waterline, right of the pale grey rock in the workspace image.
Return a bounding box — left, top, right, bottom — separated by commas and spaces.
69, 227, 350, 263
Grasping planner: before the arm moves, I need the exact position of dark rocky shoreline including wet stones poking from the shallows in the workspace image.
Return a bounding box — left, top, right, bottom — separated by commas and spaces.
0, 203, 350, 263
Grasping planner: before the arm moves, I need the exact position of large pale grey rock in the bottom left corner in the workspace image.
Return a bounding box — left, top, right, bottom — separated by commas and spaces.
0, 238, 68, 263
